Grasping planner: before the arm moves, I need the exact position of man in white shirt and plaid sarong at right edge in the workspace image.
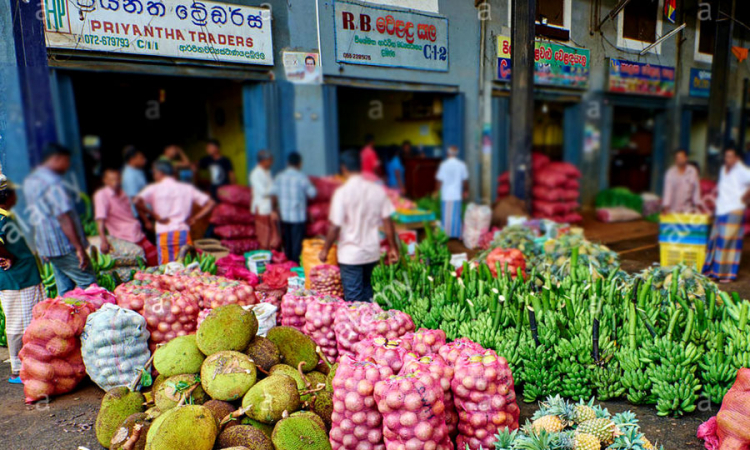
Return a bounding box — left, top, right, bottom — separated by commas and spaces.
703, 147, 750, 283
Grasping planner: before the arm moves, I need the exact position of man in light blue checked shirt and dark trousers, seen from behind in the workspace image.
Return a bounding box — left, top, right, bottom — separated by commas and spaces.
271, 152, 316, 263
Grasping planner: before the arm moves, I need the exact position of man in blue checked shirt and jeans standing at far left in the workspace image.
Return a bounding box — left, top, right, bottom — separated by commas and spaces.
23, 144, 96, 296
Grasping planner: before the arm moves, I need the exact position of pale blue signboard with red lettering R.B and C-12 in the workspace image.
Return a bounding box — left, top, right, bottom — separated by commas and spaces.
333, 0, 449, 72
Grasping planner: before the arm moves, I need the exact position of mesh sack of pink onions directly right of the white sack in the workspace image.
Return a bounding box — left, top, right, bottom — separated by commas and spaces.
143, 292, 200, 353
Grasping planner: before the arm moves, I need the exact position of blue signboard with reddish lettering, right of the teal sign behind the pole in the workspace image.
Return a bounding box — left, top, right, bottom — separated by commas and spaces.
609, 58, 675, 97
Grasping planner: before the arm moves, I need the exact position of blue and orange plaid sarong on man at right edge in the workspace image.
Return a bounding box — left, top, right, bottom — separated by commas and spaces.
703, 210, 745, 280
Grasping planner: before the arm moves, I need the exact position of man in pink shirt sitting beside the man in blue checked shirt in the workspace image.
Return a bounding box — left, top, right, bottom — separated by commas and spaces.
94, 169, 158, 266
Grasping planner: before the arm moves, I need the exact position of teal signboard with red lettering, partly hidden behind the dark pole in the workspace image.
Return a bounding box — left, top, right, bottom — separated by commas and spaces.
497, 36, 591, 89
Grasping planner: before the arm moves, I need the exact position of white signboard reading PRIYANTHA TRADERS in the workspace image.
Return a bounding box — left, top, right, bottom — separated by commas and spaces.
42, 0, 273, 65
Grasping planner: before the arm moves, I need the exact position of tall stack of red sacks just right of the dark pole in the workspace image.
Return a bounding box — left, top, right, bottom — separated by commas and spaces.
532, 159, 583, 223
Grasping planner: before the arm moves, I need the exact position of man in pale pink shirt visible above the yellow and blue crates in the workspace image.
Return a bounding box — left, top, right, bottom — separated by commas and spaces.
662, 149, 701, 213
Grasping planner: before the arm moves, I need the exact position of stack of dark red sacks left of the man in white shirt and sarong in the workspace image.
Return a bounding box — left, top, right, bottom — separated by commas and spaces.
211, 185, 260, 255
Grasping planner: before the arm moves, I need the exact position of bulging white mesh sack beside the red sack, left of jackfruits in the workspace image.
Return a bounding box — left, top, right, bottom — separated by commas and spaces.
81, 303, 151, 391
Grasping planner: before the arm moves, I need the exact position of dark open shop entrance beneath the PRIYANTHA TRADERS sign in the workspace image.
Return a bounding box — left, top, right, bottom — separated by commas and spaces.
66, 72, 247, 190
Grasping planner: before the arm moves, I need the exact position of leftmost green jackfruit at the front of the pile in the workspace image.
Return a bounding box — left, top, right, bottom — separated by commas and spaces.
94, 386, 146, 447
